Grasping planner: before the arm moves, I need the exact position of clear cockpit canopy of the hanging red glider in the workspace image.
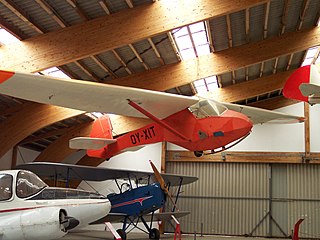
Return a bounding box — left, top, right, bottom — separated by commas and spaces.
189, 99, 227, 118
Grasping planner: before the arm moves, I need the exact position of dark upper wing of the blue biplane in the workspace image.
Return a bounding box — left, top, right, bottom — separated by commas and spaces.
16, 162, 198, 186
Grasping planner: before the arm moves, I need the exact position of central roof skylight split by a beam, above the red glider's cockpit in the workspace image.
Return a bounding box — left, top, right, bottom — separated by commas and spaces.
172, 22, 219, 93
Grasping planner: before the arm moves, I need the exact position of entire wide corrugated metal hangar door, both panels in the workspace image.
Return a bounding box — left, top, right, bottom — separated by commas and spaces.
165, 162, 320, 238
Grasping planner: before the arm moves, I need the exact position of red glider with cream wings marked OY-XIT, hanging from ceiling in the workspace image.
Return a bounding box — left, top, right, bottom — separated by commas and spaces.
0, 71, 303, 159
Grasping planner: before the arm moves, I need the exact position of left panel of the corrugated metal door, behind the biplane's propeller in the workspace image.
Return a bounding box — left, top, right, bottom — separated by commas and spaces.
166, 162, 269, 236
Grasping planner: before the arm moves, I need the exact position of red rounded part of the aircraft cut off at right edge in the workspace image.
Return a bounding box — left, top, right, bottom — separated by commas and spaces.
282, 65, 310, 102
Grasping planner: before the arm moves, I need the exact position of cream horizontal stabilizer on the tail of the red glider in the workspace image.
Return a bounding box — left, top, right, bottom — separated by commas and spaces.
69, 137, 117, 150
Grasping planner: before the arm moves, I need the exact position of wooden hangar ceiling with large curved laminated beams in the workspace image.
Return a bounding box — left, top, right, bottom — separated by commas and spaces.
0, 0, 320, 165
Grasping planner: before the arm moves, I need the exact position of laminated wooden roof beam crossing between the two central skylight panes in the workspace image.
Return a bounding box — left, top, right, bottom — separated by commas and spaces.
108, 27, 320, 91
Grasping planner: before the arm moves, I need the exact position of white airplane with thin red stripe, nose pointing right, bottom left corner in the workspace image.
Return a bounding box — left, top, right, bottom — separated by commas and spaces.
0, 170, 111, 240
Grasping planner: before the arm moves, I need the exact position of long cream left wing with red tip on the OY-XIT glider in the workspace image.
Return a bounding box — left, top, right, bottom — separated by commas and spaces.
0, 70, 199, 119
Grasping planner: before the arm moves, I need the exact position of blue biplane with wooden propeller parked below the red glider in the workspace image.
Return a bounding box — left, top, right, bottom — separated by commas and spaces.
17, 161, 198, 240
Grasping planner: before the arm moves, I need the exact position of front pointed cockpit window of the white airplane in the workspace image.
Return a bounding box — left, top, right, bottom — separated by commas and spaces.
16, 171, 47, 198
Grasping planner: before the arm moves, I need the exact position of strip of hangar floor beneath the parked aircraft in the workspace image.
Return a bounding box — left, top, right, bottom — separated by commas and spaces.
62, 230, 283, 240
